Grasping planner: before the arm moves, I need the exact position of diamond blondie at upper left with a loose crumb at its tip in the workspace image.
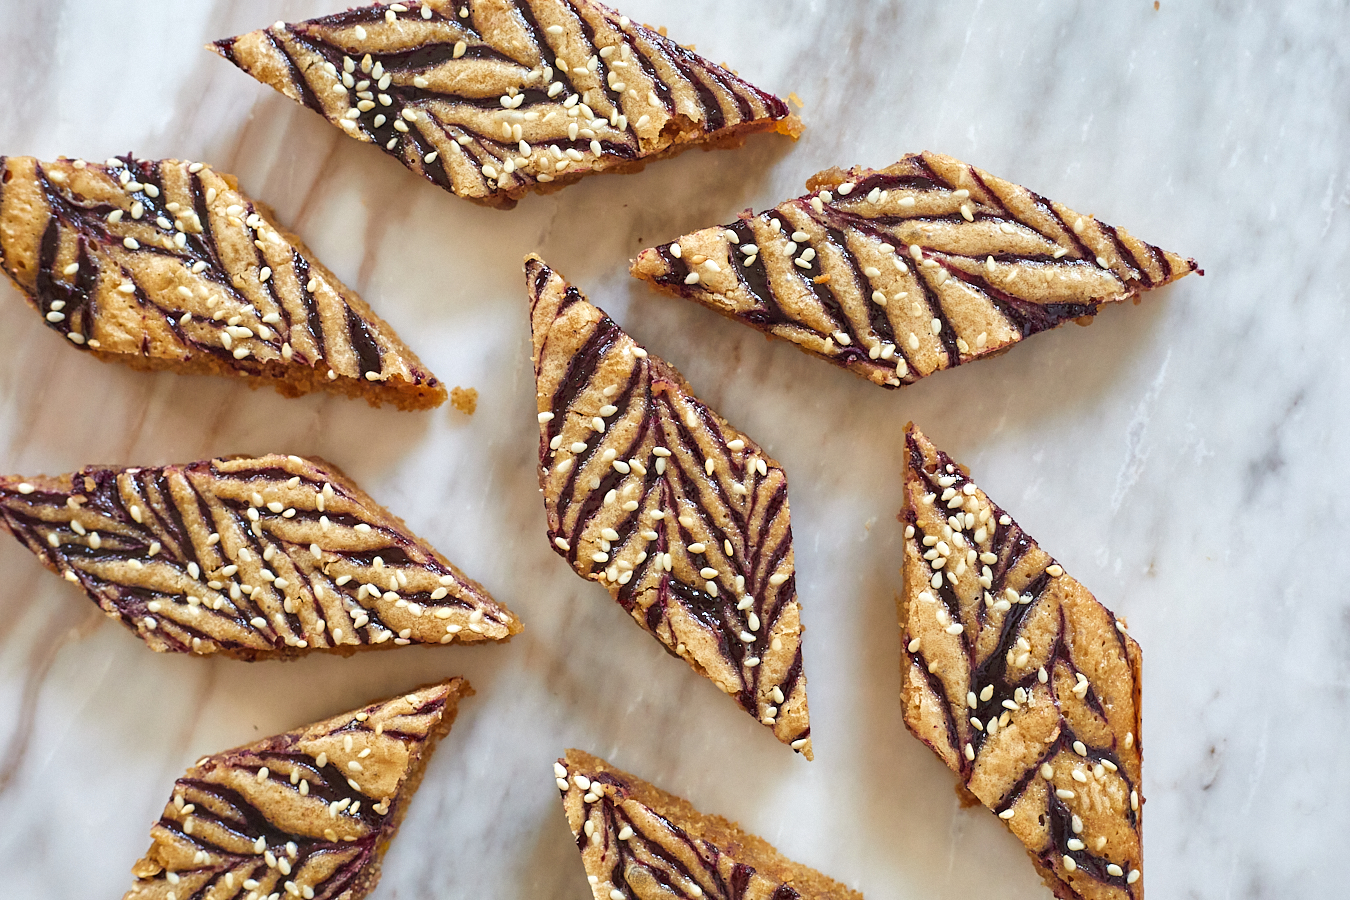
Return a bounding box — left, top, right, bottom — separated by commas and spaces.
0, 155, 446, 409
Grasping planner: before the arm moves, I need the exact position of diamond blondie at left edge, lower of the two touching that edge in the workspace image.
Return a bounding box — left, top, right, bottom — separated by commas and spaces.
0, 455, 520, 660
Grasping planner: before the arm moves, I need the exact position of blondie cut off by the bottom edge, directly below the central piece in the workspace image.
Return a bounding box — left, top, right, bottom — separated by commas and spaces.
554, 750, 863, 900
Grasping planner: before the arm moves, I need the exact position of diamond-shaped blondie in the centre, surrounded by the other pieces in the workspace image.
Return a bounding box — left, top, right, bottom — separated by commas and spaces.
525, 256, 811, 758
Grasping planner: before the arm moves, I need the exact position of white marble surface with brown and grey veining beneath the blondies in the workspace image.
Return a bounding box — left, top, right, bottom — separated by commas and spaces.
0, 0, 1350, 900
